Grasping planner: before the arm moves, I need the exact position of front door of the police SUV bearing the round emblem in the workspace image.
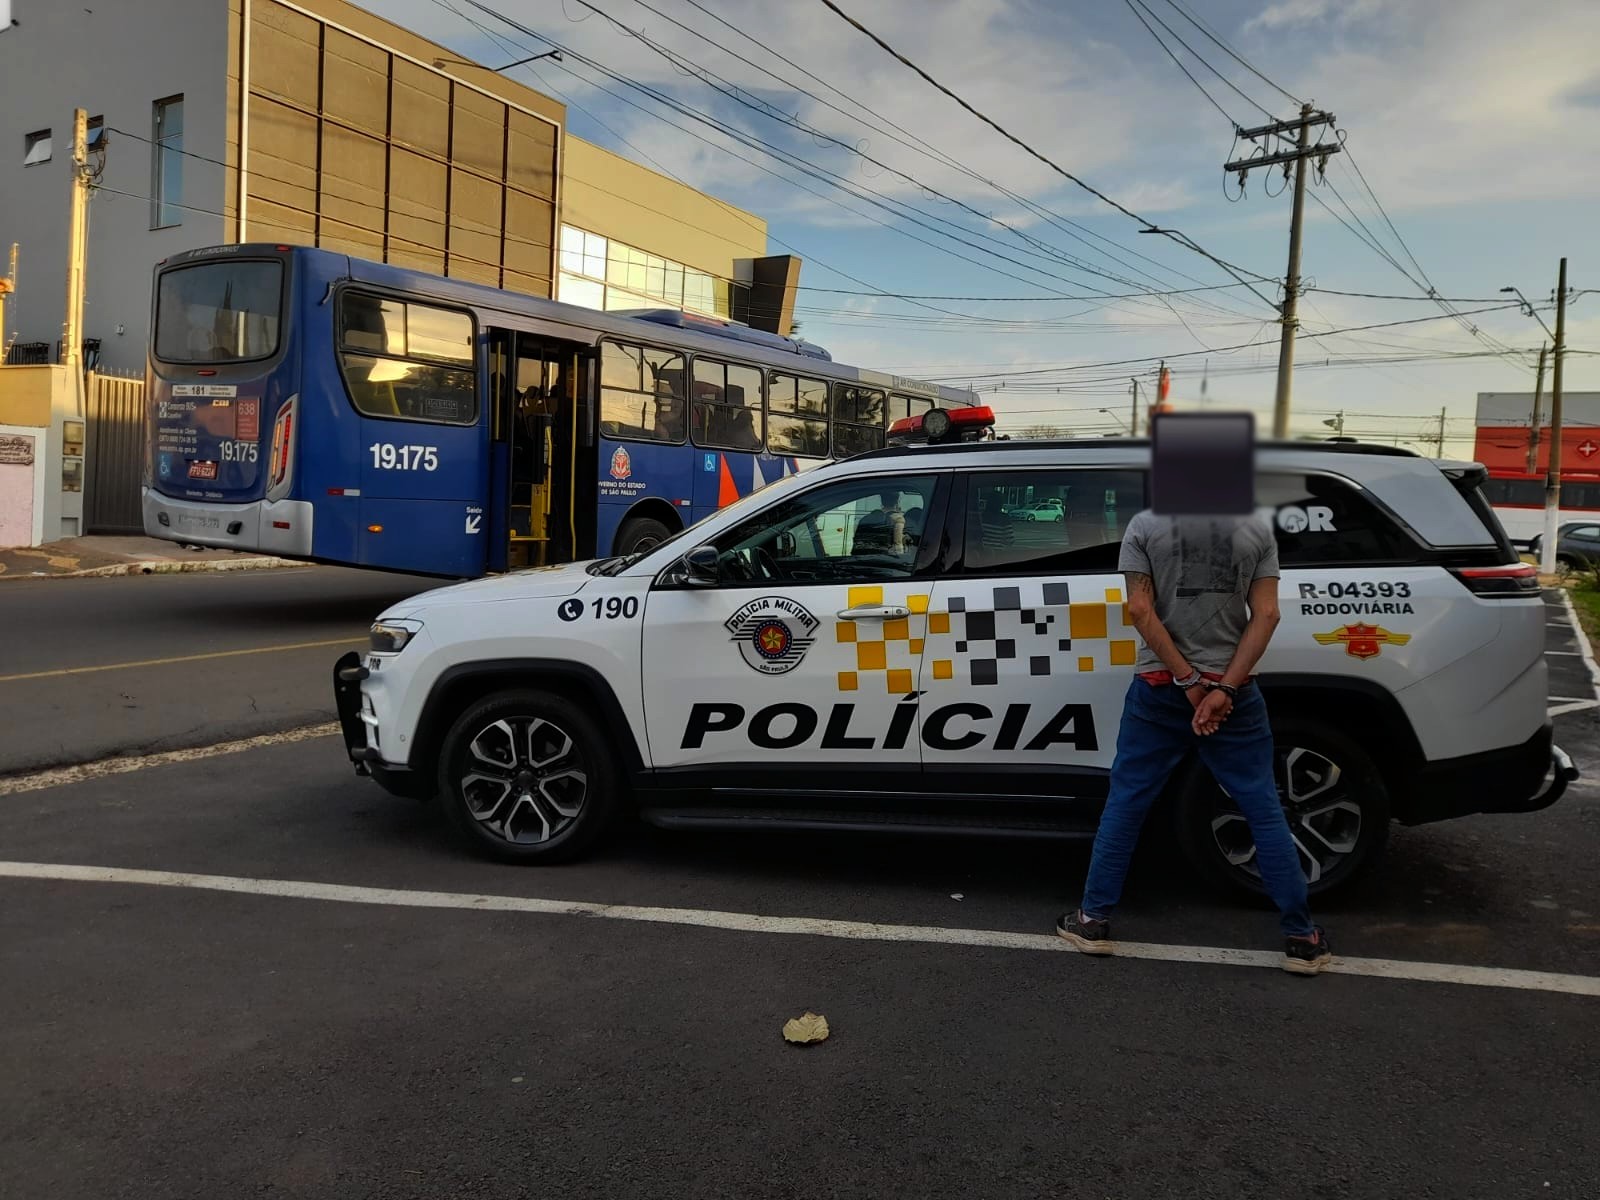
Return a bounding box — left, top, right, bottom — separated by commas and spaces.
642, 472, 944, 792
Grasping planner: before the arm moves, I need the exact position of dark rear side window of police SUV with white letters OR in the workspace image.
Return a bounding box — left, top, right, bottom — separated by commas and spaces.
1256, 472, 1416, 566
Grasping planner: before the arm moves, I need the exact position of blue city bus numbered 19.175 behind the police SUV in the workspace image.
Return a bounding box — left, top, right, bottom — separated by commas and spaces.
142, 245, 976, 578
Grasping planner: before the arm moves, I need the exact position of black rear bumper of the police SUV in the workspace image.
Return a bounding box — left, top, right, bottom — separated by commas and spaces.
1395, 725, 1578, 826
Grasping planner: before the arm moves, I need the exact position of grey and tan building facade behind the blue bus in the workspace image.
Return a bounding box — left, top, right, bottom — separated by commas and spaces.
0, 0, 798, 373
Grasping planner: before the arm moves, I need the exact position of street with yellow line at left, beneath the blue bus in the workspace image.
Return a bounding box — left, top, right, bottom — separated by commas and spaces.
0, 566, 440, 774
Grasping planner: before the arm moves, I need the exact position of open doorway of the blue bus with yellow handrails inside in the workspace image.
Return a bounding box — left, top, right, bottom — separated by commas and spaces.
490, 330, 584, 570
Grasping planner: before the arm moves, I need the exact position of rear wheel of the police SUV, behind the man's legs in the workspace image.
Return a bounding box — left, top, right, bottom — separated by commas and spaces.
1174, 717, 1389, 896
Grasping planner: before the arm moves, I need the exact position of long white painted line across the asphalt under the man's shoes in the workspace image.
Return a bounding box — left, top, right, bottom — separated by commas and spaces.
0, 862, 1600, 997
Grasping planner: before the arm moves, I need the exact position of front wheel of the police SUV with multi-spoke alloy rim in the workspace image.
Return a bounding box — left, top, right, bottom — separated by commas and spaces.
438, 690, 622, 862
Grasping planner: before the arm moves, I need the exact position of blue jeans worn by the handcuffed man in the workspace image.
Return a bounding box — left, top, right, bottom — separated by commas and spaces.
1083, 678, 1314, 938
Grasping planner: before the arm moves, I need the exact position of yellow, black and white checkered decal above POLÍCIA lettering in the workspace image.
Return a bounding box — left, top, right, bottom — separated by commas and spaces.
835, 582, 1138, 696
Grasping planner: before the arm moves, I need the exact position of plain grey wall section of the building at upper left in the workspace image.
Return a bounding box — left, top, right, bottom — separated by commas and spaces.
0, 0, 229, 371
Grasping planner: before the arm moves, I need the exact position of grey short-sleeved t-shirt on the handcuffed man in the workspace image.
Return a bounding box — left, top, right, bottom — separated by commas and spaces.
1117, 510, 1278, 674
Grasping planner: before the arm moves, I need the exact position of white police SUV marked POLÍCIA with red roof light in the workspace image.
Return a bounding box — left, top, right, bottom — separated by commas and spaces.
334, 410, 1576, 891
